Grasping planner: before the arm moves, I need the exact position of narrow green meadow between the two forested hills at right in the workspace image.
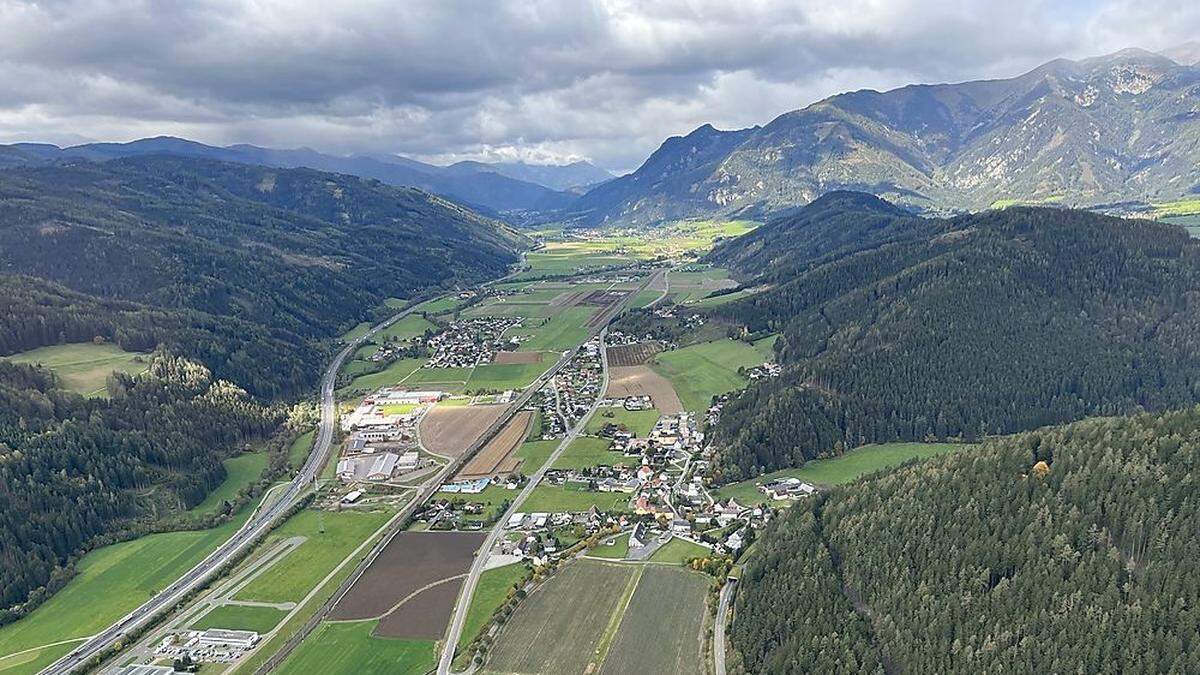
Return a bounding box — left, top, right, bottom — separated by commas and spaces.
716, 443, 970, 504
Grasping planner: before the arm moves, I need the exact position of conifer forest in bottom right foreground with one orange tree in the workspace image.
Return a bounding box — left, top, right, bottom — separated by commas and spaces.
731, 407, 1200, 674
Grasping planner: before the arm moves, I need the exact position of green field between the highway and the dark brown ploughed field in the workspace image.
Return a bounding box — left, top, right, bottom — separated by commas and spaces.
235, 509, 391, 603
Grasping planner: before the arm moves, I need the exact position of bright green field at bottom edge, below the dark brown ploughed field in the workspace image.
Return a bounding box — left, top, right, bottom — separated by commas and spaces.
278, 621, 437, 675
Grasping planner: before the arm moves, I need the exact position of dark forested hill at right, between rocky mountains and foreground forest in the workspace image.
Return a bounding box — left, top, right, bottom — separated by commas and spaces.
712, 195, 1200, 480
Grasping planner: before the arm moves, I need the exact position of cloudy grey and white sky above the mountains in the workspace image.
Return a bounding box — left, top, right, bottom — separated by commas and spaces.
0, 0, 1200, 171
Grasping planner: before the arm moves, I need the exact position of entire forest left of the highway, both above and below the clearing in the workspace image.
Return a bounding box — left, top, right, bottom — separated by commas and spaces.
0, 156, 528, 621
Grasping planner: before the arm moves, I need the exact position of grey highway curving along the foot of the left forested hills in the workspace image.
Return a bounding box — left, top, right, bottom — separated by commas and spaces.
42, 302, 429, 675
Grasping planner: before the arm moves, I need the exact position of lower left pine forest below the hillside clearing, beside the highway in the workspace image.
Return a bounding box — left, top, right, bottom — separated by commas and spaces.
0, 353, 280, 608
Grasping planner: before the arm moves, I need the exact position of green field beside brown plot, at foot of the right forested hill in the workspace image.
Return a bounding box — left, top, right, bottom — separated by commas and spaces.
652, 339, 773, 412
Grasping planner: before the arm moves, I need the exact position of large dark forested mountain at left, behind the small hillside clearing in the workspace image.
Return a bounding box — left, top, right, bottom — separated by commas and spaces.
0, 156, 527, 394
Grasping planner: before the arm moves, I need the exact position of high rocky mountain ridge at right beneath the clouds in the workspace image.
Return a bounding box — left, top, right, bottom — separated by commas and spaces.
571, 44, 1200, 225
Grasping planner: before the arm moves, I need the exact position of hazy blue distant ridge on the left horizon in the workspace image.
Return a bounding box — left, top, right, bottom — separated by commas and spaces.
0, 136, 588, 220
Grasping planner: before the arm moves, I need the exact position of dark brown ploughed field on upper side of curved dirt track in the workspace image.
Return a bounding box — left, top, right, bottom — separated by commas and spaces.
330, 532, 484, 619
